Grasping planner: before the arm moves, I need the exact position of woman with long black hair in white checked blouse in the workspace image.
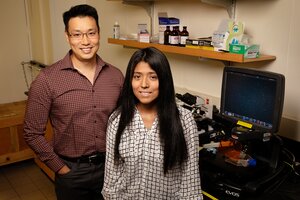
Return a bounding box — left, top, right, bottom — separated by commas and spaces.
102, 47, 202, 200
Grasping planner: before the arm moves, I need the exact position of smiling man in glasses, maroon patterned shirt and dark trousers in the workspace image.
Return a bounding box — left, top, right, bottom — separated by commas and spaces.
24, 5, 124, 200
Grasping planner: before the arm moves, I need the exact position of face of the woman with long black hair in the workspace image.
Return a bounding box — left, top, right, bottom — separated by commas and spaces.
131, 61, 159, 106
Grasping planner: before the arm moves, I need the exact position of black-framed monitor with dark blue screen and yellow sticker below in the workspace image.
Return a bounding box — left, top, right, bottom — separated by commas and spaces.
220, 67, 285, 133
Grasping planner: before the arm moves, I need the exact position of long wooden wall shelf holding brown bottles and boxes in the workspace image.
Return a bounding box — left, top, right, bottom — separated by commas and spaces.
108, 38, 276, 63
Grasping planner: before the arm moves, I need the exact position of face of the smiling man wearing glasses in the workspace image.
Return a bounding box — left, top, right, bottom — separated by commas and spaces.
65, 16, 100, 62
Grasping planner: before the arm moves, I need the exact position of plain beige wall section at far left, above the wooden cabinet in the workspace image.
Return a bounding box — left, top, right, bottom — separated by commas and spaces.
0, 0, 30, 103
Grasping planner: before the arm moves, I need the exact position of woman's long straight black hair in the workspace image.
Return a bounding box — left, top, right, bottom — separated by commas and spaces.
115, 47, 187, 174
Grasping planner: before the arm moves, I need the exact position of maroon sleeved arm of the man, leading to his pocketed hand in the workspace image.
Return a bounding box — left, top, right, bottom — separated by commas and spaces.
24, 72, 64, 172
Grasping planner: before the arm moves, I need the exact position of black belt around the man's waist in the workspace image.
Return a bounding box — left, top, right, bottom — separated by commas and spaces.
58, 152, 105, 165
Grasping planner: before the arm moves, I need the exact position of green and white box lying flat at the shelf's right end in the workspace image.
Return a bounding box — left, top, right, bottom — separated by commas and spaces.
229, 44, 259, 58
